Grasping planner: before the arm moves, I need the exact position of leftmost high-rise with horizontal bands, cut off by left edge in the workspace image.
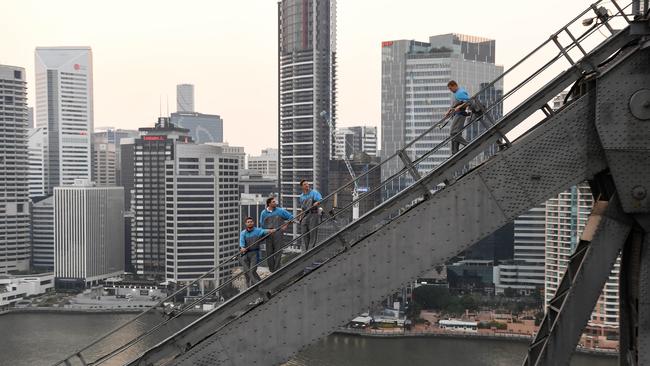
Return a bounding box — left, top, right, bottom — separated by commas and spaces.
0, 65, 30, 274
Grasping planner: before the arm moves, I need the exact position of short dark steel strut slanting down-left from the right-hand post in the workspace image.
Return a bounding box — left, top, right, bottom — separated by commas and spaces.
524, 198, 634, 366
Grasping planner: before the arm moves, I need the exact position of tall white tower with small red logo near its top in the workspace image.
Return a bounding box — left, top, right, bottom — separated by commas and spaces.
35, 47, 93, 195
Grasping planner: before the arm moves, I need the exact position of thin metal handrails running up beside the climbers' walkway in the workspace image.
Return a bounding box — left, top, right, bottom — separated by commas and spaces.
56, 0, 629, 365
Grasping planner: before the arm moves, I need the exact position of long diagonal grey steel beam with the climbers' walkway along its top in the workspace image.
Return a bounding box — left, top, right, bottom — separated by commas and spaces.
125, 27, 632, 365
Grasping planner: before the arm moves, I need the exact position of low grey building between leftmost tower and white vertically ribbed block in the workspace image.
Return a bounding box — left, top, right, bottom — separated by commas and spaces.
32, 196, 54, 271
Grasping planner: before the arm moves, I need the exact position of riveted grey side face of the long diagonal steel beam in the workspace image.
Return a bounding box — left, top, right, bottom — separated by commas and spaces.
159, 91, 607, 365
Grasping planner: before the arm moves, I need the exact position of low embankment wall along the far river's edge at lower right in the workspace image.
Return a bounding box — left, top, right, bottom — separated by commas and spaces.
333, 328, 618, 357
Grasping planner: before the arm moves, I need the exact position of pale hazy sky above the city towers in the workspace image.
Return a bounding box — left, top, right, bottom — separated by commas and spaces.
0, 0, 584, 154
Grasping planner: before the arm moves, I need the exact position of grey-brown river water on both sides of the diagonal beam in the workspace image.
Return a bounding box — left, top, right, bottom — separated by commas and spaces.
0, 314, 616, 366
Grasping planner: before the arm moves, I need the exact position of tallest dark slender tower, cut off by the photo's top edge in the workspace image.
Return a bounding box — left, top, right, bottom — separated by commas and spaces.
278, 0, 336, 220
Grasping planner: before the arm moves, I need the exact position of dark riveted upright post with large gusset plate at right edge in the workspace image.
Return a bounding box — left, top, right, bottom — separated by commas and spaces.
595, 45, 650, 366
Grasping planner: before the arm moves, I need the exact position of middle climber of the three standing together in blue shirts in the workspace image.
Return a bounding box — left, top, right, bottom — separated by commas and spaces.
259, 197, 293, 272
